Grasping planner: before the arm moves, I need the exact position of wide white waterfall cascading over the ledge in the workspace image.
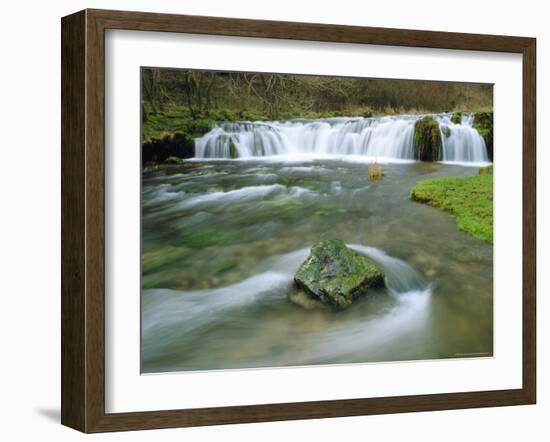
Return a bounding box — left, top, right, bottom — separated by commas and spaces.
195, 114, 488, 163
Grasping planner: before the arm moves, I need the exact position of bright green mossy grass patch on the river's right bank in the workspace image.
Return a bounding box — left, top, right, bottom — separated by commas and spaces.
411, 173, 493, 243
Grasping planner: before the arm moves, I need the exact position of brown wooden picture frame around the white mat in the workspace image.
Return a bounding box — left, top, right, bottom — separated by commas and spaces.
61, 10, 536, 433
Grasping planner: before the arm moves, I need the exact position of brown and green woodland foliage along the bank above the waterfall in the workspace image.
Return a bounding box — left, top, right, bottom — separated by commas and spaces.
141, 68, 492, 122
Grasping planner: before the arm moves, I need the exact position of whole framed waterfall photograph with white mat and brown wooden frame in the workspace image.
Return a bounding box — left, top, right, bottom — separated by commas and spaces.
61, 10, 536, 432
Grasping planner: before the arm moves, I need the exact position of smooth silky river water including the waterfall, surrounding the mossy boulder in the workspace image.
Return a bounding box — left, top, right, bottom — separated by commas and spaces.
141, 116, 493, 373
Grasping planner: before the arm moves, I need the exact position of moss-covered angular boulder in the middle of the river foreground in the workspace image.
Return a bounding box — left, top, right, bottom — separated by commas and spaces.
294, 239, 384, 308
